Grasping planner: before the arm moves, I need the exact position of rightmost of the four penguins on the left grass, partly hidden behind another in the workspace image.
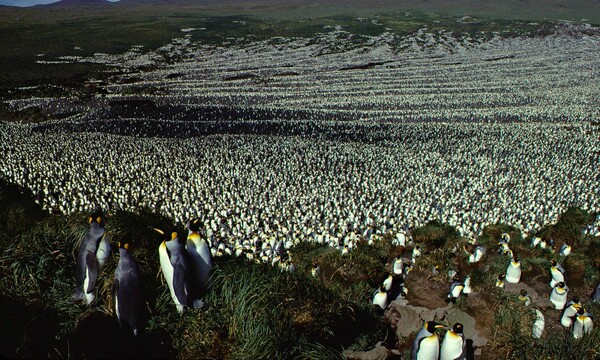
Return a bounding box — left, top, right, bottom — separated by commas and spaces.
185, 219, 212, 308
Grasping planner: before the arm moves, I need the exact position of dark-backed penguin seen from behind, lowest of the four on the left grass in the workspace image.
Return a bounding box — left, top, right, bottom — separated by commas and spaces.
113, 243, 145, 336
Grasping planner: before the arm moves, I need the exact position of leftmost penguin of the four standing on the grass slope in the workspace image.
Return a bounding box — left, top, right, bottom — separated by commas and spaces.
73, 212, 111, 304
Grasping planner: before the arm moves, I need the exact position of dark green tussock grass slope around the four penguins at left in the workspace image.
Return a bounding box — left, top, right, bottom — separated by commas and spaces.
0, 179, 393, 359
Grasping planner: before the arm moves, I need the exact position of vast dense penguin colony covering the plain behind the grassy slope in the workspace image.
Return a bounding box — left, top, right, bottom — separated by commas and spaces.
0, 24, 600, 242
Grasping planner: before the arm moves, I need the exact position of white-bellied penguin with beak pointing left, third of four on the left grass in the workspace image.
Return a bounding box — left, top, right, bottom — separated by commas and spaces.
154, 229, 191, 313
